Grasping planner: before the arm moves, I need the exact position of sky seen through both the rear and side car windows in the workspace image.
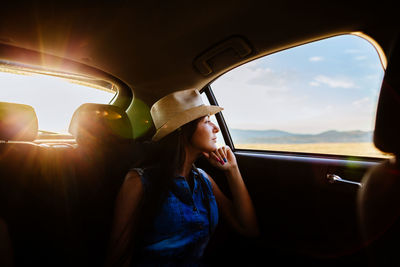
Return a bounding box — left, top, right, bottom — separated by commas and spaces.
0, 35, 384, 134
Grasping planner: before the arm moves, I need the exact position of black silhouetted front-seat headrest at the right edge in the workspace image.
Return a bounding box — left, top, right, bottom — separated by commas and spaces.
374, 37, 400, 155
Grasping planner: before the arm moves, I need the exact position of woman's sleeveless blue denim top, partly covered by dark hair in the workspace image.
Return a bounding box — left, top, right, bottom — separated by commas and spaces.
132, 168, 218, 266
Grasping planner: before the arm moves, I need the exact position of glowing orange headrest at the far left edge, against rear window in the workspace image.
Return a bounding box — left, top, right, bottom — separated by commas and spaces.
0, 102, 38, 141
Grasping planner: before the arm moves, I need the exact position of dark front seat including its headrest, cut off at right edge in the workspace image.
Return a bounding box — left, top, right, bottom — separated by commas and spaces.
357, 37, 400, 265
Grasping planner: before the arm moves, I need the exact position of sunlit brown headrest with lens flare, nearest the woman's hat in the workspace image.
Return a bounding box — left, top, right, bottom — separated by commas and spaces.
69, 103, 133, 146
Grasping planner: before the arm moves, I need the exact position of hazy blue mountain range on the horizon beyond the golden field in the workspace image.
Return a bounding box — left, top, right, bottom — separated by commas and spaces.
230, 129, 372, 144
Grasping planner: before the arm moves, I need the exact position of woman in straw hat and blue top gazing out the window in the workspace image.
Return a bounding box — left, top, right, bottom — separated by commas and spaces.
107, 89, 258, 266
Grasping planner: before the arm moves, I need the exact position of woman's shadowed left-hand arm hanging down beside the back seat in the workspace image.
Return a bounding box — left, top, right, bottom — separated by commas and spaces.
106, 171, 144, 266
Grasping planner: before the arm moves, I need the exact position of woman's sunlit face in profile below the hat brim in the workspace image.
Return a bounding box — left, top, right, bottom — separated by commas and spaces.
190, 116, 219, 152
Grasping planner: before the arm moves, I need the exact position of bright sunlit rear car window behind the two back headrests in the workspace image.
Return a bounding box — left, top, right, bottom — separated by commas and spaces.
0, 68, 116, 138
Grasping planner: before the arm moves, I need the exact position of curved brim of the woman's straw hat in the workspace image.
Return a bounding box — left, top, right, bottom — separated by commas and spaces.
152, 105, 223, 141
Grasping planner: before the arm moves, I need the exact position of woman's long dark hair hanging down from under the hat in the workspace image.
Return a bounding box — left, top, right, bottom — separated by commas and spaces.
115, 117, 203, 263
